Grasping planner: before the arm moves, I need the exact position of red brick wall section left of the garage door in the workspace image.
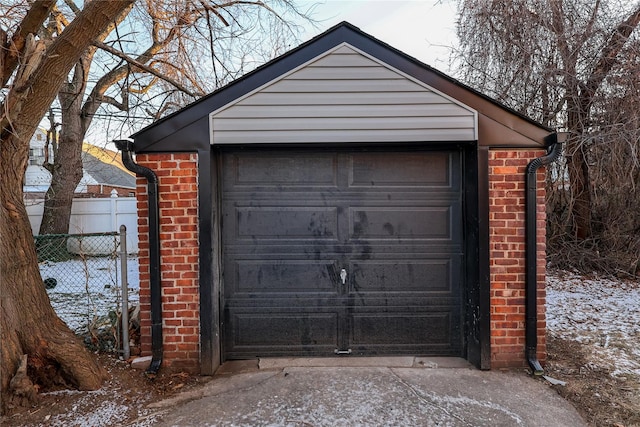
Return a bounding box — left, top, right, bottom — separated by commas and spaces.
136, 153, 200, 371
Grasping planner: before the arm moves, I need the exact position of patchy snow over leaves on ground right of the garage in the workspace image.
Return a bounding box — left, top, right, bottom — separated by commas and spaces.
547, 272, 640, 378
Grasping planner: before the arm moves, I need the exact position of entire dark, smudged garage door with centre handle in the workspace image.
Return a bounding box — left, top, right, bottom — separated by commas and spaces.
222, 150, 463, 359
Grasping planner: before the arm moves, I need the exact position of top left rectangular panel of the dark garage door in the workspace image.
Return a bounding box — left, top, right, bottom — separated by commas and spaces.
224, 152, 338, 190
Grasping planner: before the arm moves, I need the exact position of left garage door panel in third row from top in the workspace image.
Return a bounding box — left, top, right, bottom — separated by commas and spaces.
228, 259, 338, 297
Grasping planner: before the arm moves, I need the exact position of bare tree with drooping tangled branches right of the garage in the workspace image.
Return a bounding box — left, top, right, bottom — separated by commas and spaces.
455, 0, 640, 270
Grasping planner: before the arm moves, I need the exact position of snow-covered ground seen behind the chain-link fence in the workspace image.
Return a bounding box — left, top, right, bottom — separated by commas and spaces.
40, 257, 140, 333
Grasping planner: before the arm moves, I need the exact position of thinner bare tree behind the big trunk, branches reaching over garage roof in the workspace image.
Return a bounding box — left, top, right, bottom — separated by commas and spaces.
40, 0, 305, 234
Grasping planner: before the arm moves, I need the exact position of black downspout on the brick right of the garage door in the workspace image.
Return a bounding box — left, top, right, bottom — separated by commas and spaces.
525, 133, 562, 375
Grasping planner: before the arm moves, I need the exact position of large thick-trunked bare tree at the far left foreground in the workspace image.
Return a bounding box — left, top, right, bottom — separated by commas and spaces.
0, 0, 133, 409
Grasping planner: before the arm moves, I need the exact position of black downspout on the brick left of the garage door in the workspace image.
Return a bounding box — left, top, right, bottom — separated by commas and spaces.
113, 139, 162, 378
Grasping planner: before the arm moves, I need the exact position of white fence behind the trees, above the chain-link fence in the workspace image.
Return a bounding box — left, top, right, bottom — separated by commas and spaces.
25, 196, 138, 253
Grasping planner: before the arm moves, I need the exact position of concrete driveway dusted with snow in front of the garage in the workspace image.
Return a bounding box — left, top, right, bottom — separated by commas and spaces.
145, 357, 586, 427
